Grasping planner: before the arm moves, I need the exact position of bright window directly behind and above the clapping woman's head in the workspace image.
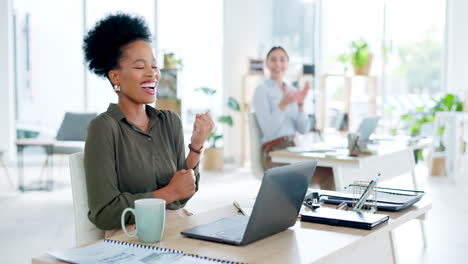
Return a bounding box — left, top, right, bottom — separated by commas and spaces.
258, 0, 318, 113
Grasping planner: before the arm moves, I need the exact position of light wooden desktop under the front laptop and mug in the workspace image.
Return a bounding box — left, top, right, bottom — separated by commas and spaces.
32, 199, 432, 264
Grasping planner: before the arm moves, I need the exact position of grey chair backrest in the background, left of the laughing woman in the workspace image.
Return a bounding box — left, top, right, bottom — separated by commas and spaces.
55, 112, 97, 141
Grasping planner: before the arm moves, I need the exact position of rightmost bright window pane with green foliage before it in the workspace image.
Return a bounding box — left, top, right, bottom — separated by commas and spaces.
385, 0, 445, 95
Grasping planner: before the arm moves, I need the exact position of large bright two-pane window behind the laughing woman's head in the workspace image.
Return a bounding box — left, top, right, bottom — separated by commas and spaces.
14, 0, 155, 136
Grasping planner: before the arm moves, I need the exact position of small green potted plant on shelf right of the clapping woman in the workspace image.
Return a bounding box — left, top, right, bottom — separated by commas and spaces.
351, 39, 372, 75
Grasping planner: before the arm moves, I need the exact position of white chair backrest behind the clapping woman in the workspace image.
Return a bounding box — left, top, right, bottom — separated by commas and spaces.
248, 112, 263, 179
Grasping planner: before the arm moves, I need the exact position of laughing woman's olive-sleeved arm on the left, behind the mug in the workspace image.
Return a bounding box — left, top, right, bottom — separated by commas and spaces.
84, 116, 153, 230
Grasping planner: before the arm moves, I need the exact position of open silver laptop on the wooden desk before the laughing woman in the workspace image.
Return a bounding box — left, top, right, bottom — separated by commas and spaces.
181, 161, 317, 245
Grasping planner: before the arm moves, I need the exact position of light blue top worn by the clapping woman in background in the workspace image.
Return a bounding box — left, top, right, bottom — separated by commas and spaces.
253, 79, 310, 144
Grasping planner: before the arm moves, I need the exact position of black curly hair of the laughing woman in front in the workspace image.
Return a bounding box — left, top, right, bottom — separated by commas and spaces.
83, 13, 151, 77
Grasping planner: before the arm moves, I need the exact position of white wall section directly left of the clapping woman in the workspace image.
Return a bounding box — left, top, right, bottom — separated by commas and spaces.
223, 0, 271, 162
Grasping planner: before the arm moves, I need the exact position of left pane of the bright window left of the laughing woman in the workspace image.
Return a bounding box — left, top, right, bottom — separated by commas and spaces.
13, 0, 84, 135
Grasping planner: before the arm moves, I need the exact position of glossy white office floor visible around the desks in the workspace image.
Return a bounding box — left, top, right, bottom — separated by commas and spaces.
0, 156, 468, 264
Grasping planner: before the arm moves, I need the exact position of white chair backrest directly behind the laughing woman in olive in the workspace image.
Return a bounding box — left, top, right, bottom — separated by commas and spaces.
69, 152, 104, 246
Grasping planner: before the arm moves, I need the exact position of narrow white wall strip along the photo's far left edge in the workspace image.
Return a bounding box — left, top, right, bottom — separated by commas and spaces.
0, 0, 16, 159
